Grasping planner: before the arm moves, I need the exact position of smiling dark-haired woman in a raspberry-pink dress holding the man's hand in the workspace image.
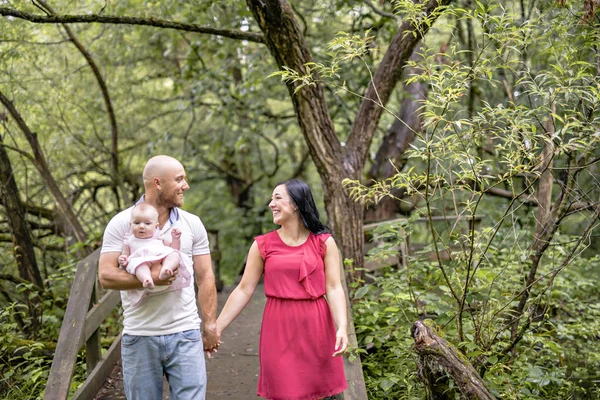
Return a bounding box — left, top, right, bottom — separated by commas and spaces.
217, 179, 348, 400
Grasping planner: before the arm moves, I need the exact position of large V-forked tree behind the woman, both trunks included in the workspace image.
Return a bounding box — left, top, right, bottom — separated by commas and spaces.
247, 0, 451, 281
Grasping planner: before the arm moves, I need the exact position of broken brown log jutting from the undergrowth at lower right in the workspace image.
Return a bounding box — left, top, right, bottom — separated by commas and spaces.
411, 321, 496, 400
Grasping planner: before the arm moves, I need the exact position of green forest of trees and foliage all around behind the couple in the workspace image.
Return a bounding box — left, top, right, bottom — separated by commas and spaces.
0, 0, 600, 400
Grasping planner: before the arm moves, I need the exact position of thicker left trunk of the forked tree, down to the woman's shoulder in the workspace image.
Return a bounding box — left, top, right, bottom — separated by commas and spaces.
247, 0, 363, 281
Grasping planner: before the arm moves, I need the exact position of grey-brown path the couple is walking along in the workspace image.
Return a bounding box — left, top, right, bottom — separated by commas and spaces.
94, 284, 266, 400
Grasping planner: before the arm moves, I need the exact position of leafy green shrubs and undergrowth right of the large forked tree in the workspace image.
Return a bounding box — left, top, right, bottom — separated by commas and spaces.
346, 2, 600, 399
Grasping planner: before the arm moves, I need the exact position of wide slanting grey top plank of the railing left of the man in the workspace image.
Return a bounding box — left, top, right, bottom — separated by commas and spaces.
44, 249, 100, 400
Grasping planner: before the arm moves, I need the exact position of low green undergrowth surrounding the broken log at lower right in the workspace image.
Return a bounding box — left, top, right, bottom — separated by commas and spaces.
353, 231, 600, 400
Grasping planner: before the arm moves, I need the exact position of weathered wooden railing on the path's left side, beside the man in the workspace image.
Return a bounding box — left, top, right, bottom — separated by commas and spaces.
44, 231, 222, 400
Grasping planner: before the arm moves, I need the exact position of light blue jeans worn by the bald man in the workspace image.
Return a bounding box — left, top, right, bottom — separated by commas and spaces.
121, 329, 206, 400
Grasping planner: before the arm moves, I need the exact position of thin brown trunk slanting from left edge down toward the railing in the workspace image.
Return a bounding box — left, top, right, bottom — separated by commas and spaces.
0, 92, 87, 242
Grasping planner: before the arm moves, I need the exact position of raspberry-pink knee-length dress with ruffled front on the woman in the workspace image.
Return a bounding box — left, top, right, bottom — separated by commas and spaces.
255, 231, 347, 400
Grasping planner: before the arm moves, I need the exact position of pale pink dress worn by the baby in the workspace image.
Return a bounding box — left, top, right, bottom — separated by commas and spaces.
124, 229, 192, 305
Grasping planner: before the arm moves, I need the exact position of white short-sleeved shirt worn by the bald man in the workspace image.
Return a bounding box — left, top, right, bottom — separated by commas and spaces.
101, 207, 210, 336
